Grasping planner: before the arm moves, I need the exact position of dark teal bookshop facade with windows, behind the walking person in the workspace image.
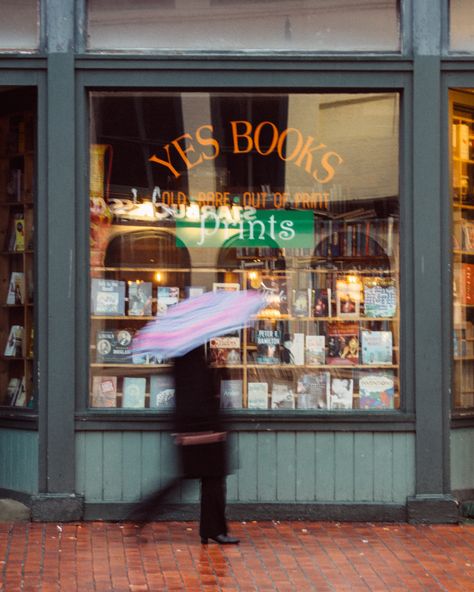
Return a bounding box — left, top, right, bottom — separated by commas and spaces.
0, 0, 474, 522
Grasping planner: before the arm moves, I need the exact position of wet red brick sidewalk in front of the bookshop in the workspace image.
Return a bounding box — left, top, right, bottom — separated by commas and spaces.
0, 522, 474, 592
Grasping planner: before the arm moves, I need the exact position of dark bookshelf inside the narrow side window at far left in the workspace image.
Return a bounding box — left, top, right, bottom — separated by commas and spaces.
0, 100, 36, 408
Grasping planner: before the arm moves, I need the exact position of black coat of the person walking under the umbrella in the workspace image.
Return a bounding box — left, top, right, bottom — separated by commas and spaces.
174, 347, 227, 478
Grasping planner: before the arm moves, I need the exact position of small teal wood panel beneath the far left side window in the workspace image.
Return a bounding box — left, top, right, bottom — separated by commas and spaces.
0, 429, 38, 493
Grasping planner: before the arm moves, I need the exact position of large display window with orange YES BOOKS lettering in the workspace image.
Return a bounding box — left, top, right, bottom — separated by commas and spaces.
89, 91, 400, 413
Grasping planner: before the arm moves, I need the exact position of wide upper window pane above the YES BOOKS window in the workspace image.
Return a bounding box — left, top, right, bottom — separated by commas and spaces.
88, 0, 400, 52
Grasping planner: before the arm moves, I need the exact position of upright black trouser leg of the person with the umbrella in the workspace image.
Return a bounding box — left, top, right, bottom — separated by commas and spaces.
199, 477, 227, 538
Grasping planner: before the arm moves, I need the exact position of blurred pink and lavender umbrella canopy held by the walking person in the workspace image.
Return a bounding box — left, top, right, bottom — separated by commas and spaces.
133, 290, 265, 358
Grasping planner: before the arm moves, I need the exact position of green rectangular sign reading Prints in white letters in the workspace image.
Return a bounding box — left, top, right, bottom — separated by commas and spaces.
176, 208, 314, 249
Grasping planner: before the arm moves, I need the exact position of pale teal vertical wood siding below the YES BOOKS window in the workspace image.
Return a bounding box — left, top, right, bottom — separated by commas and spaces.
76, 432, 415, 503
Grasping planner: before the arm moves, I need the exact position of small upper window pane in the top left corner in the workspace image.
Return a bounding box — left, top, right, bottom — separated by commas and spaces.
0, 0, 39, 51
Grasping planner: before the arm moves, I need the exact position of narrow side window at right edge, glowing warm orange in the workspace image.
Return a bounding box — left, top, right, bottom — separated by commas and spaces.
451, 90, 474, 410
